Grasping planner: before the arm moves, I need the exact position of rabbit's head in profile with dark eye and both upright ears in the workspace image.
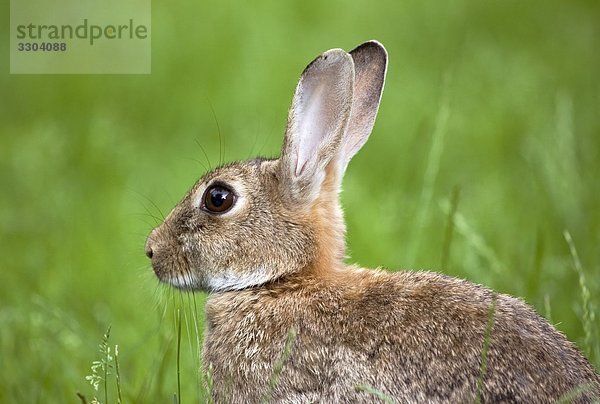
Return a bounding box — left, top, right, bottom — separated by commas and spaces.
146, 41, 387, 291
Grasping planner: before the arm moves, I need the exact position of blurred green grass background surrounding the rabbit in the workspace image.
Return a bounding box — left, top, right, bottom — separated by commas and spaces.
0, 0, 600, 403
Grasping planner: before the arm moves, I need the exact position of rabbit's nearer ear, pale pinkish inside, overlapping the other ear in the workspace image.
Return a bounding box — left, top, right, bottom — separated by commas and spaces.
280, 49, 354, 202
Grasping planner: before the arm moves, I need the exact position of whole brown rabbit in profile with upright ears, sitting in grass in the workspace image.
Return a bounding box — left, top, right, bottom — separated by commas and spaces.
145, 41, 600, 403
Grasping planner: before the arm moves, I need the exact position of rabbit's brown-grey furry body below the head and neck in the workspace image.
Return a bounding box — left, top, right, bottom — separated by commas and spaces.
204, 269, 600, 402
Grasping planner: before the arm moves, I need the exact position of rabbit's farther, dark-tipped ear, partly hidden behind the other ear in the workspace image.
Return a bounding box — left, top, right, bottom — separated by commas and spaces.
341, 41, 387, 172
